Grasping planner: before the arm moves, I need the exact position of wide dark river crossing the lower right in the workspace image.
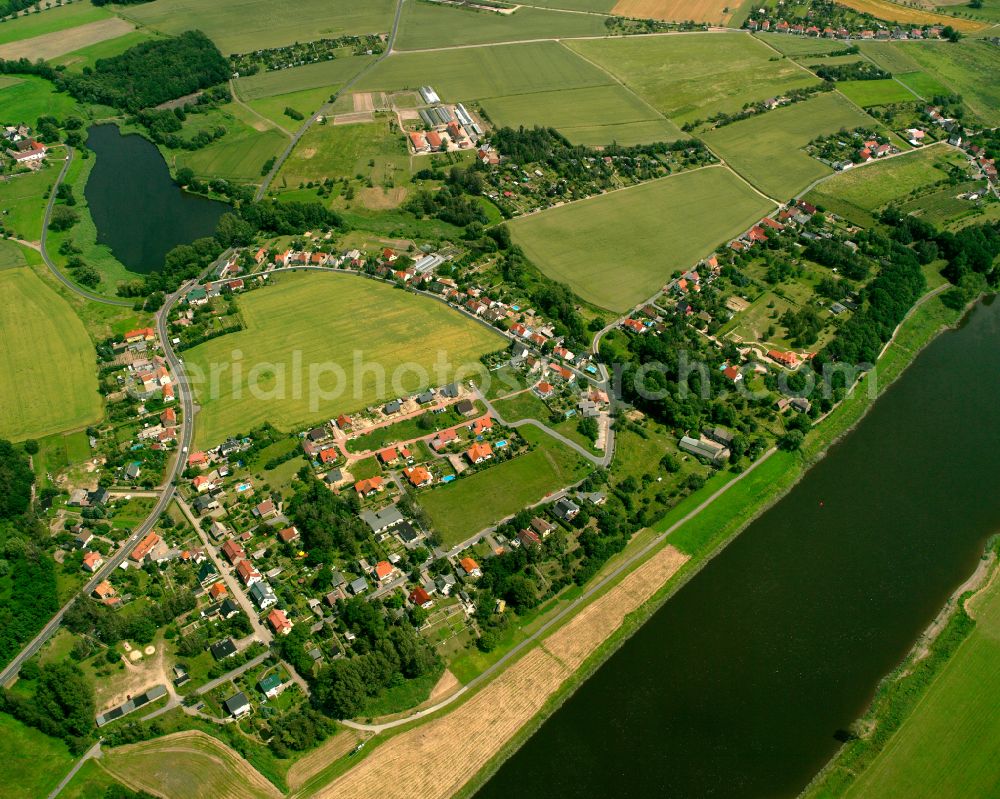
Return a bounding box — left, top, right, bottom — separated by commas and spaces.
477, 301, 1000, 799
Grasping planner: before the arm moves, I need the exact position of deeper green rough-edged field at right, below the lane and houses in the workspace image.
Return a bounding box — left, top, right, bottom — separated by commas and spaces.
807, 145, 965, 225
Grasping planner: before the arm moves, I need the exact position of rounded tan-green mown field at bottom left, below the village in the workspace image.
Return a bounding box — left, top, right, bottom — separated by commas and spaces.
101, 730, 281, 799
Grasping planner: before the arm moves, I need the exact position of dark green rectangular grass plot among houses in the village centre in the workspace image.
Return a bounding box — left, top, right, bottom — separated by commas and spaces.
418, 427, 590, 547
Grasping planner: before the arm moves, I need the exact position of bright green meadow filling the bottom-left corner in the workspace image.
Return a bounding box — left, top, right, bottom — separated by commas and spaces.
0, 713, 76, 799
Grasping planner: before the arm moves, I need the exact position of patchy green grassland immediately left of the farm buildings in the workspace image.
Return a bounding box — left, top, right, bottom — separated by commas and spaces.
272, 117, 410, 190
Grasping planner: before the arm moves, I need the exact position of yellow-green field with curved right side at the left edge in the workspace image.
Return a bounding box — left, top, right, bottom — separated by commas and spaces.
0, 247, 102, 440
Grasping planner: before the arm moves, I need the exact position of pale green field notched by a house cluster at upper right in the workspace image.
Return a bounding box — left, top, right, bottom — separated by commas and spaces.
704, 92, 876, 199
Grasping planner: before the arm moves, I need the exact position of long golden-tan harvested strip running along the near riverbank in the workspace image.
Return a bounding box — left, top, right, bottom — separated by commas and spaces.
315, 546, 687, 799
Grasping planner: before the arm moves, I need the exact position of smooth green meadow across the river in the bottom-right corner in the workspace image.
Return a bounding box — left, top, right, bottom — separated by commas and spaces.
846, 568, 1000, 799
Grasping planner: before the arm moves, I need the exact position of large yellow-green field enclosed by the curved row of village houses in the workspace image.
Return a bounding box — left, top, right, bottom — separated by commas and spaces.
185, 274, 505, 446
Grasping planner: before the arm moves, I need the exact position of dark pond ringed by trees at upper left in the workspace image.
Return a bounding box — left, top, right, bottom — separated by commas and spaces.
84, 125, 229, 274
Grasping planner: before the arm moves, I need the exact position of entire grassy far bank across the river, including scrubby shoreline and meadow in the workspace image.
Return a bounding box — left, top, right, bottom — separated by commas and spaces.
802, 536, 1000, 799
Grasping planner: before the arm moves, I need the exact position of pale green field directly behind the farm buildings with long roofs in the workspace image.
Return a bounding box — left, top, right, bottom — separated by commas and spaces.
356, 42, 614, 102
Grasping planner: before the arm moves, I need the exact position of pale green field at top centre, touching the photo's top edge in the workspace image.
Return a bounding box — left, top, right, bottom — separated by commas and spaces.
395, 2, 607, 50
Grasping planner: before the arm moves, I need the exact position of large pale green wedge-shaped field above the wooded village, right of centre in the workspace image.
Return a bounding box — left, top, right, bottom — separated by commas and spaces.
510, 167, 774, 311
